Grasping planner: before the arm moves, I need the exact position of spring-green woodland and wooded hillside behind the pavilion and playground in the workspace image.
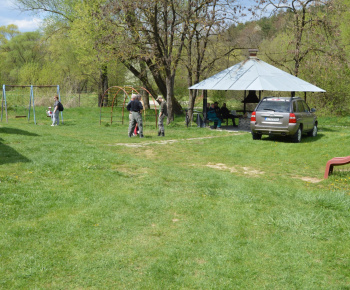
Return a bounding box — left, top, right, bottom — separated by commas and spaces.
0, 0, 350, 122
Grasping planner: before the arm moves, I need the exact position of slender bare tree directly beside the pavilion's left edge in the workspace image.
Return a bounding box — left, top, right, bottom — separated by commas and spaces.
184, 1, 244, 118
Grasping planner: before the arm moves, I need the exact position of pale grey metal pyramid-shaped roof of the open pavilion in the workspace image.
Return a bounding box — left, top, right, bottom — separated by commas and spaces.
189, 57, 325, 92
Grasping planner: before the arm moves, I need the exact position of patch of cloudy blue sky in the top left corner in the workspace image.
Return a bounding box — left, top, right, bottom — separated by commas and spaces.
0, 0, 42, 32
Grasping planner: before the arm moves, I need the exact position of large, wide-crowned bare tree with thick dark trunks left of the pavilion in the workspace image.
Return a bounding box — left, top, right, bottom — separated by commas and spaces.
90, 0, 243, 122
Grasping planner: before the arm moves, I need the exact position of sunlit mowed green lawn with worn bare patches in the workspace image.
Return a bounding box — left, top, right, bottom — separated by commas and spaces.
0, 108, 350, 289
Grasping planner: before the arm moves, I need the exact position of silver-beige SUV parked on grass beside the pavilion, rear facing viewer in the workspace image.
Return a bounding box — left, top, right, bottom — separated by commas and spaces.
250, 97, 317, 143
